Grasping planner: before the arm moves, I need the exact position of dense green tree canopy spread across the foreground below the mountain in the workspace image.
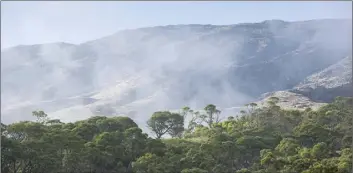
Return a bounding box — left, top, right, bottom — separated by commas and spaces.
1, 97, 353, 173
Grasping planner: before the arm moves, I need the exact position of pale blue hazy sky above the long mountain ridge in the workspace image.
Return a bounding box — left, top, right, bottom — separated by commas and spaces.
1, 1, 352, 49
